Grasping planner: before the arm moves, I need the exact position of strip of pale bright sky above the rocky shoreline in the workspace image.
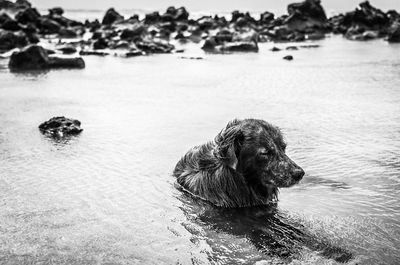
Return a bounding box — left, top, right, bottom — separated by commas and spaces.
32, 0, 400, 14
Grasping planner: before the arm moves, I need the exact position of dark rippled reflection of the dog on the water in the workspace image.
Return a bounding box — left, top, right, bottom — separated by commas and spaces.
178, 190, 353, 263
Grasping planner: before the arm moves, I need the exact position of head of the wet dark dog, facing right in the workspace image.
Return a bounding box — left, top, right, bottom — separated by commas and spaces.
215, 119, 304, 193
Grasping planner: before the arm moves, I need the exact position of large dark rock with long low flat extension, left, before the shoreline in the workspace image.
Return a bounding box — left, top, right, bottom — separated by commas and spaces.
8, 45, 85, 71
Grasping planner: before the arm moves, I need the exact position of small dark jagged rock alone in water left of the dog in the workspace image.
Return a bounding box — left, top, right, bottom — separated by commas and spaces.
39, 116, 83, 137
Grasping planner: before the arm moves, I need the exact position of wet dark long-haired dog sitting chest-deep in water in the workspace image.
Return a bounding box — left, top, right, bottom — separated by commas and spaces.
173, 119, 304, 208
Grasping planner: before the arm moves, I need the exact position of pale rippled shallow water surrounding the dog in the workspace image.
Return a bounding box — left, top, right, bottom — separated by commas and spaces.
0, 37, 400, 264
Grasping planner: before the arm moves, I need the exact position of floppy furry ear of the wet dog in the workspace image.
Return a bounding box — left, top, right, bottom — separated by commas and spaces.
215, 120, 244, 170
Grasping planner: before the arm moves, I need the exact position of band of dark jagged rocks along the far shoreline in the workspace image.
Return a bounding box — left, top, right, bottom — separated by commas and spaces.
0, 0, 400, 70
